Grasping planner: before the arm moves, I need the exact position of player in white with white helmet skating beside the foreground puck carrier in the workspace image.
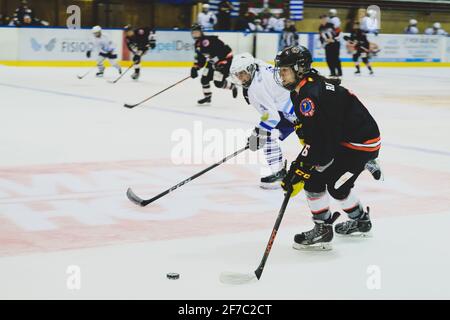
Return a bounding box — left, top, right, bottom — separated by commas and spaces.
230, 53, 297, 189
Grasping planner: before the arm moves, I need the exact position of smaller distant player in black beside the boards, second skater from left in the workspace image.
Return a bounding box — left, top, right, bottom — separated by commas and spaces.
124, 25, 156, 80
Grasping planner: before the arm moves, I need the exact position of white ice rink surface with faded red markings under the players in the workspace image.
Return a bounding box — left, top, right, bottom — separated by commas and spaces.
0, 66, 450, 299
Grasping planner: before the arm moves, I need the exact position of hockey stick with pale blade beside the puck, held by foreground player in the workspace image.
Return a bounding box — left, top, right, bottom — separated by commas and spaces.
220, 192, 291, 284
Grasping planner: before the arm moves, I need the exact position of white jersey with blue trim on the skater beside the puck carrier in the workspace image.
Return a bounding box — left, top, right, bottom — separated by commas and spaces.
248, 61, 297, 131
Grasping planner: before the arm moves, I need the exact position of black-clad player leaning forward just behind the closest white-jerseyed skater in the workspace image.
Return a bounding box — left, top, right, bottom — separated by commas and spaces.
191, 24, 238, 104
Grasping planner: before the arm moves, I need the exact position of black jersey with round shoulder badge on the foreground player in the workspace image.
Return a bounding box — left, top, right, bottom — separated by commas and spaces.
291, 74, 381, 166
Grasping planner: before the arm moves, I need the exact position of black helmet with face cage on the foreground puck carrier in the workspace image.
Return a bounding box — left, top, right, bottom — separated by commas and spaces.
274, 46, 312, 91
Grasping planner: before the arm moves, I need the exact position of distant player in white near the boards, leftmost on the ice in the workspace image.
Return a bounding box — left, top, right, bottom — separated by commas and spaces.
86, 26, 122, 77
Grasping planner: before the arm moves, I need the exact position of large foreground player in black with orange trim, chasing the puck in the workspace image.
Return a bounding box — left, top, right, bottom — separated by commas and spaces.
275, 46, 381, 249
